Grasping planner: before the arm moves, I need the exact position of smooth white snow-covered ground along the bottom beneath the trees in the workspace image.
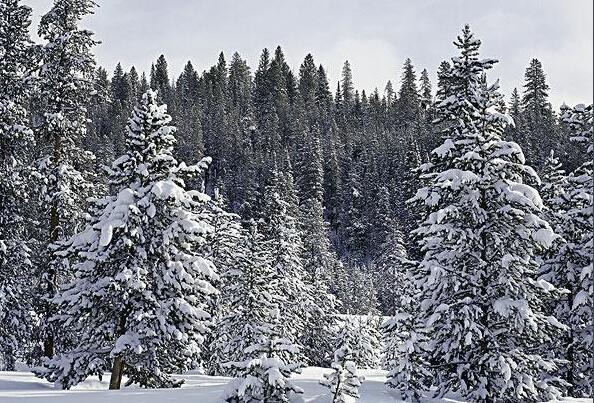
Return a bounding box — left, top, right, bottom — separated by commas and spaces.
0, 367, 590, 403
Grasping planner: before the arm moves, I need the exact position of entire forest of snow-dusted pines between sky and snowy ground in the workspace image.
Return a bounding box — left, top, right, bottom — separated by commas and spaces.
0, 0, 594, 402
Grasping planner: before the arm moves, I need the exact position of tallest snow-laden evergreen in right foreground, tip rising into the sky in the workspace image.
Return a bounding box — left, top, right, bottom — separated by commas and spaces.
402, 26, 564, 401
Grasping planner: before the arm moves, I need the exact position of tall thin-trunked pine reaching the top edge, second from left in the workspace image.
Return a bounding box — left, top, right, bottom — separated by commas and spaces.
37, 0, 96, 357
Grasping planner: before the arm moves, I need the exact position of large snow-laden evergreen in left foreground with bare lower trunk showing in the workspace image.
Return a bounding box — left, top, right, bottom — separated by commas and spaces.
37, 91, 218, 389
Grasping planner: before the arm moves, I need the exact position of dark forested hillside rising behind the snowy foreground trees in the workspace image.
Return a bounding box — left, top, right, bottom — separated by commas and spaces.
87, 47, 582, 313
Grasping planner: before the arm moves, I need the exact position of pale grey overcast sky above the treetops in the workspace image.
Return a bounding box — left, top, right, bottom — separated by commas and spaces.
24, 0, 593, 107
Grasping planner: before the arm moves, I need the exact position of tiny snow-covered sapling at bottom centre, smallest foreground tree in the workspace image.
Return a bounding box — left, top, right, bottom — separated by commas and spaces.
320, 320, 364, 403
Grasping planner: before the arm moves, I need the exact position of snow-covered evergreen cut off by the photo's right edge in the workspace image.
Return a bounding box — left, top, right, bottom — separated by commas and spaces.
543, 105, 594, 397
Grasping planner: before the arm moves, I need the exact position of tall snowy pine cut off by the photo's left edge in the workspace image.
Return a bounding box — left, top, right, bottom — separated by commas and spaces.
0, 0, 35, 371
